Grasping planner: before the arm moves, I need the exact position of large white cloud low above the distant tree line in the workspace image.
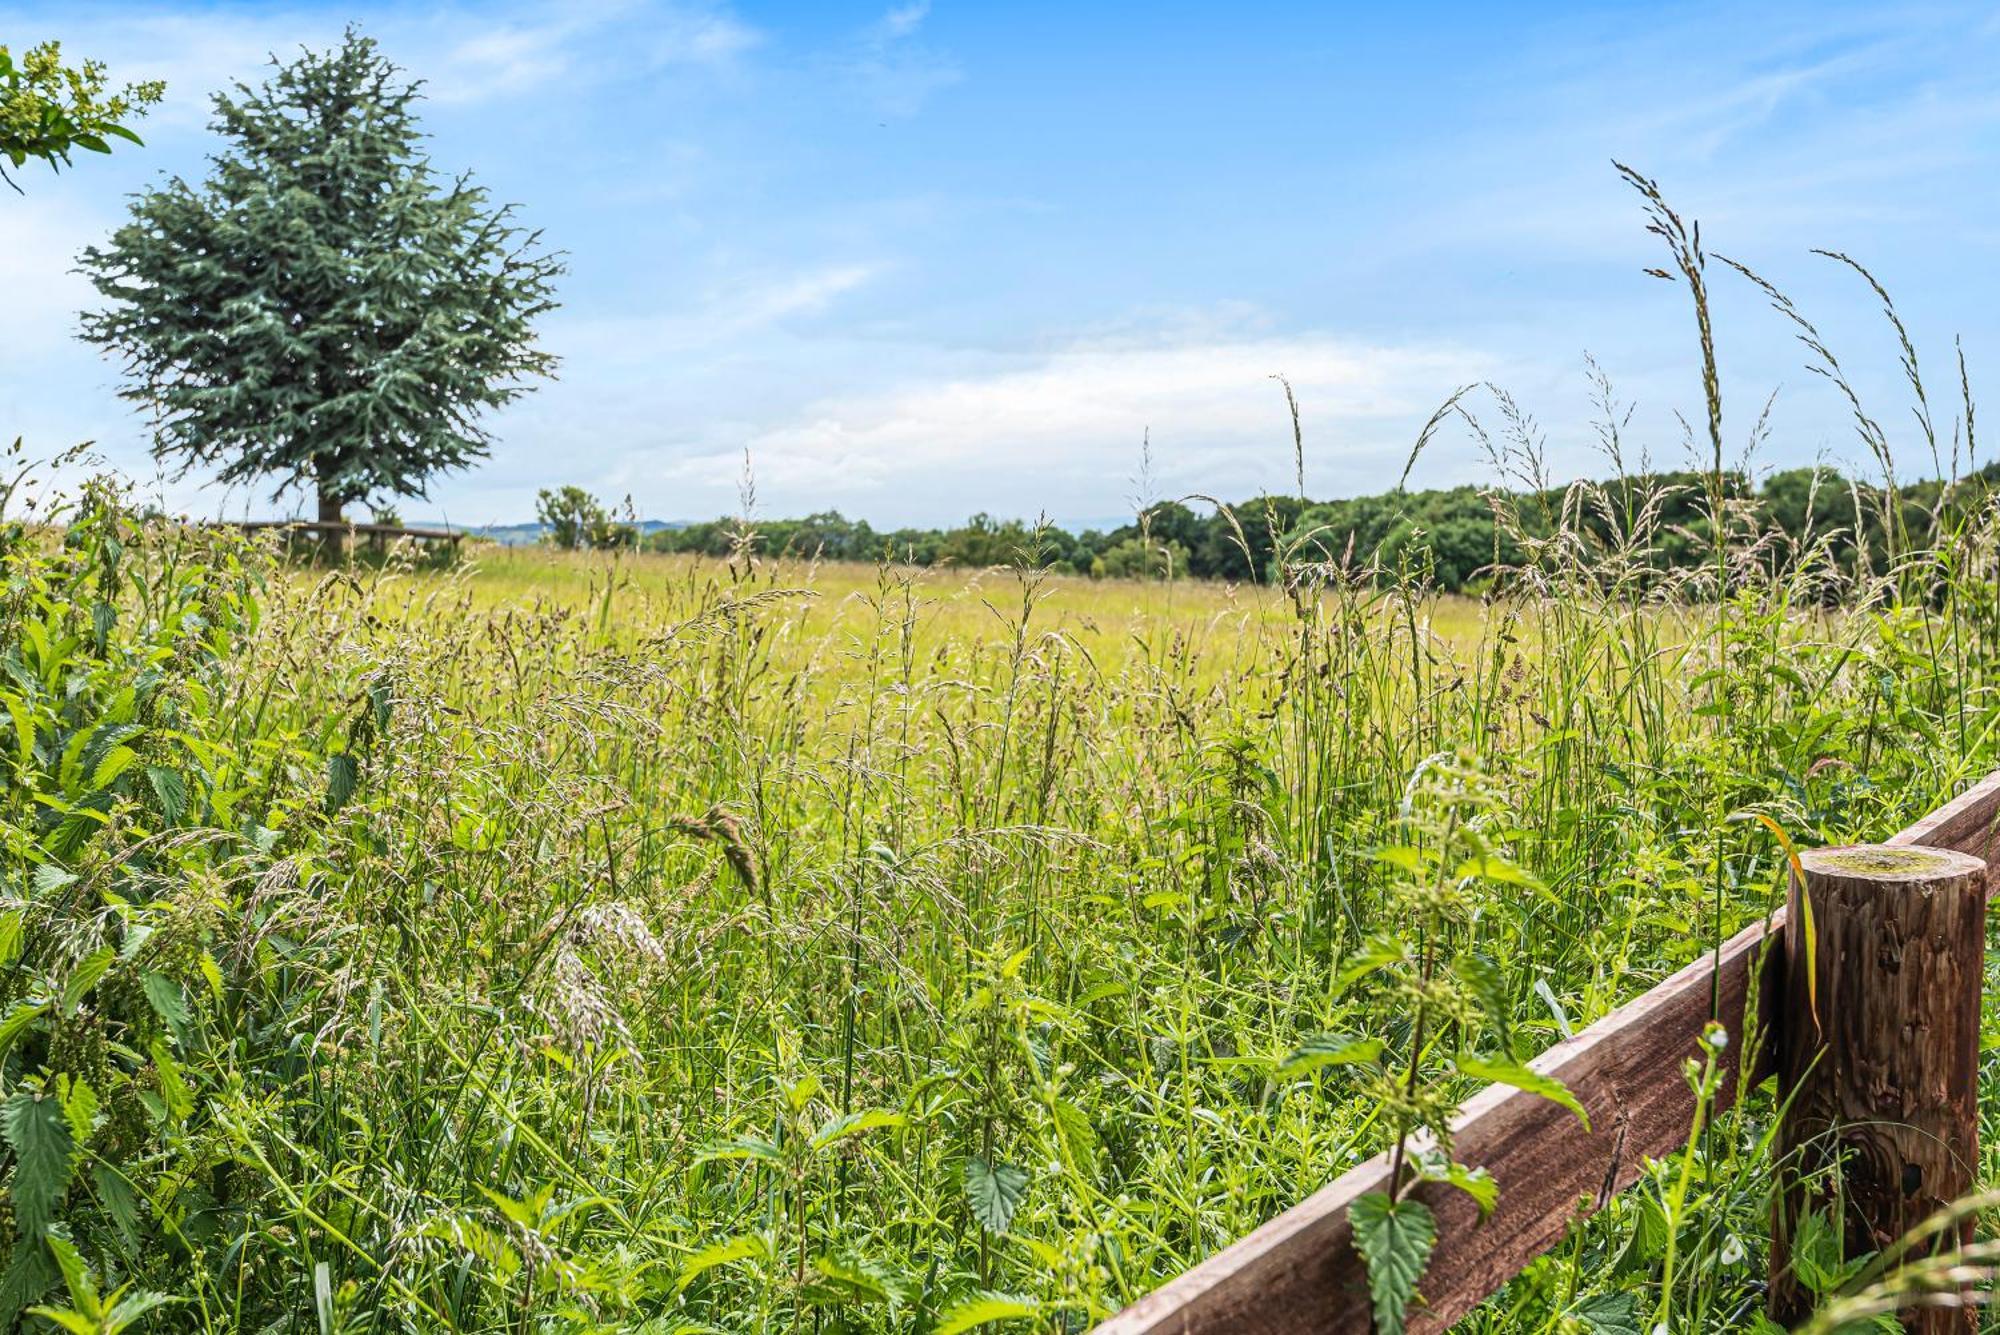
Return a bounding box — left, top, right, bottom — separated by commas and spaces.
656, 325, 1494, 520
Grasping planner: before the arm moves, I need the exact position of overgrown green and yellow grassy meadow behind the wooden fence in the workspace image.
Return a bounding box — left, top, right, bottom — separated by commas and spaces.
11, 433, 2000, 1333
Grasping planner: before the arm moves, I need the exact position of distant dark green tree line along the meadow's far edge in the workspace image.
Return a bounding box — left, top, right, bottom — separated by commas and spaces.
538, 464, 2000, 592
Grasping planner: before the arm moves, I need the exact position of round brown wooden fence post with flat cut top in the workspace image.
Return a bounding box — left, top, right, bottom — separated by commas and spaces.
1770, 843, 1986, 1335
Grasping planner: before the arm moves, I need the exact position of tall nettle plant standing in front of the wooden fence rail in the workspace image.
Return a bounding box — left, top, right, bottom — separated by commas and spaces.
1284, 753, 1590, 1335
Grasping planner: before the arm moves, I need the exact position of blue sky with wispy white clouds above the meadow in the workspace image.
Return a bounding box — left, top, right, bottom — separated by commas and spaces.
0, 0, 2000, 524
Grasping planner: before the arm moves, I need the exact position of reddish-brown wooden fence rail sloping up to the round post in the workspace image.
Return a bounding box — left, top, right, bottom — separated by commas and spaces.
1096, 773, 2000, 1335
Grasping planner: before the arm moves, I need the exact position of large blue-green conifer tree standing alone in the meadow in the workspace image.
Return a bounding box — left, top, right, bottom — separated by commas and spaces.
82, 30, 562, 520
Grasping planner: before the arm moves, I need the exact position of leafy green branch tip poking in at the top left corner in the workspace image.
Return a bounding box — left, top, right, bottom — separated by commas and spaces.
0, 42, 166, 192
